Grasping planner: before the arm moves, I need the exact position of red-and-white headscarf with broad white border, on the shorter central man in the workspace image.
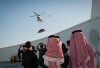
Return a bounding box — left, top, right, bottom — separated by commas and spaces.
43, 37, 64, 68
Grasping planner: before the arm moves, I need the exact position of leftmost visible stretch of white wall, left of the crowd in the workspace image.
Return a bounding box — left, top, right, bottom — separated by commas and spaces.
0, 45, 19, 62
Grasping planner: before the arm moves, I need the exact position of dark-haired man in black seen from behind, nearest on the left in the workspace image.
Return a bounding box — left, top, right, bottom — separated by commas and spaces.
23, 41, 38, 68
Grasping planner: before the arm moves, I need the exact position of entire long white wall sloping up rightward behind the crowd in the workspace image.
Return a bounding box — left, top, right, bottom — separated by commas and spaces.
0, 17, 100, 61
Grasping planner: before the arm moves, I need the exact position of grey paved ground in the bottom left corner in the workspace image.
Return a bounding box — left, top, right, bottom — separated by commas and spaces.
0, 62, 41, 68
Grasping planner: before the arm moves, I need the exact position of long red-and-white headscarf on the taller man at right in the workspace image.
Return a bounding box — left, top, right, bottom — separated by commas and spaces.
70, 32, 95, 68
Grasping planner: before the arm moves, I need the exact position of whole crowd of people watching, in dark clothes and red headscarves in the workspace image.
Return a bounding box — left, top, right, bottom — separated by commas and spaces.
18, 30, 96, 68
